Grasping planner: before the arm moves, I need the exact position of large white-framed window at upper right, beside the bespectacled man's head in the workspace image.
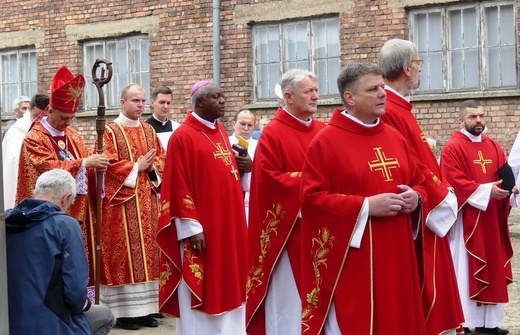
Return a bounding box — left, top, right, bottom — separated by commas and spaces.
409, 1, 517, 93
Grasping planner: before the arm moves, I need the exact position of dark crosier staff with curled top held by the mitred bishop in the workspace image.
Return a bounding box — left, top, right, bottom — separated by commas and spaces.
92, 59, 112, 304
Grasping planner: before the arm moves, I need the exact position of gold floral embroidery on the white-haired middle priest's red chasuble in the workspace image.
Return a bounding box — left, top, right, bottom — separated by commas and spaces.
246, 203, 285, 297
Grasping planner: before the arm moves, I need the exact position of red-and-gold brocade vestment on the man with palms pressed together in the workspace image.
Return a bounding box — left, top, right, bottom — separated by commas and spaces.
101, 122, 165, 286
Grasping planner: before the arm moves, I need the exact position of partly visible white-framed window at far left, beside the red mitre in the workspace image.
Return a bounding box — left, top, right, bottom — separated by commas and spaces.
0, 49, 38, 115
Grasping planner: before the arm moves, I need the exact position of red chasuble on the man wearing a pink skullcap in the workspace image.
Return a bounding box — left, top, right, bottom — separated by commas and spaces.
157, 112, 247, 317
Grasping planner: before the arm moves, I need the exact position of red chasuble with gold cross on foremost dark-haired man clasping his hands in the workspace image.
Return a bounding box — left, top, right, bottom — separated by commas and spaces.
300, 110, 426, 335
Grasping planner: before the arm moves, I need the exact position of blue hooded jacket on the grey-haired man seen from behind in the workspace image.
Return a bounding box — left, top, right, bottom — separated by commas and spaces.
5, 199, 91, 335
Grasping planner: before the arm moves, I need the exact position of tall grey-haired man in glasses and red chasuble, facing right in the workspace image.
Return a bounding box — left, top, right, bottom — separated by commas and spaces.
379, 39, 464, 335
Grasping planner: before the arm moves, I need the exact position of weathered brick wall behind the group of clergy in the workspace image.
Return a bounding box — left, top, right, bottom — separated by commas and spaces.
0, 0, 520, 151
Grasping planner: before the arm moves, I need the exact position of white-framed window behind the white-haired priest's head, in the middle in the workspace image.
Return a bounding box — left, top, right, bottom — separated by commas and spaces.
253, 17, 340, 100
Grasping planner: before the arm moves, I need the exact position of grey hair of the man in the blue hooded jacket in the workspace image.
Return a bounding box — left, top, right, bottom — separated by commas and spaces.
33, 169, 76, 205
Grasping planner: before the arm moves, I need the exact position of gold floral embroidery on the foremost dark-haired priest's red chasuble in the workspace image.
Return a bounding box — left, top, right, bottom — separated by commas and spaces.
302, 228, 336, 333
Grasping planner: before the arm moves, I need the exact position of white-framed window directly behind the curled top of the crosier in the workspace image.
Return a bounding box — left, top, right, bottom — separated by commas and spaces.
83, 36, 150, 110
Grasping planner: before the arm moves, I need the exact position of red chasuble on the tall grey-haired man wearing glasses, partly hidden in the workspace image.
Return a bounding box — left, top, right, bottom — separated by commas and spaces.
381, 90, 464, 335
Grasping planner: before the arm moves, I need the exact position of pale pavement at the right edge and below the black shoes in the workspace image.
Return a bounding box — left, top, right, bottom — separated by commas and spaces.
110, 209, 520, 335
